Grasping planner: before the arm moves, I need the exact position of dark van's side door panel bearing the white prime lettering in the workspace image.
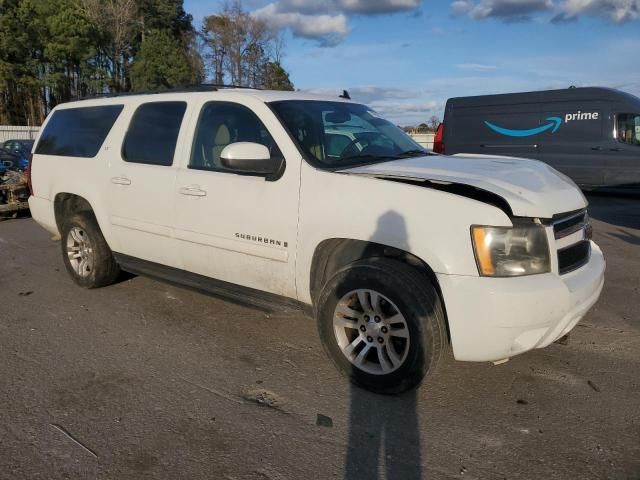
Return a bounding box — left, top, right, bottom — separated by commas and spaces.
539, 101, 610, 186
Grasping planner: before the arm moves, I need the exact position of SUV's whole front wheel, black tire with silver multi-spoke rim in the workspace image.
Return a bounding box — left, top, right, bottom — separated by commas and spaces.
317, 258, 446, 394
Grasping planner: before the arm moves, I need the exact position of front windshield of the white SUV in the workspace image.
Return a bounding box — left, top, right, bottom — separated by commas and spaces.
271, 100, 428, 169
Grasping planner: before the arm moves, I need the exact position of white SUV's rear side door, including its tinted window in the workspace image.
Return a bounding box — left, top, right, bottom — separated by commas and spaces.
109, 101, 187, 267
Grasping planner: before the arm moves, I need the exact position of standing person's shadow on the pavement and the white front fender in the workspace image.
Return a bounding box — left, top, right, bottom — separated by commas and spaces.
344, 211, 422, 480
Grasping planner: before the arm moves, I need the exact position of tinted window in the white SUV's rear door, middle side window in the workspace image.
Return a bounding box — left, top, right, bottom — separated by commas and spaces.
122, 102, 187, 166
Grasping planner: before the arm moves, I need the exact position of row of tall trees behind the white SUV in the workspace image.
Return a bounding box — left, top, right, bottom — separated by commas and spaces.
0, 0, 293, 125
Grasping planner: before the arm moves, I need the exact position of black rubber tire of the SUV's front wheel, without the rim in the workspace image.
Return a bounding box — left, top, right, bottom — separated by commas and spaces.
317, 258, 446, 394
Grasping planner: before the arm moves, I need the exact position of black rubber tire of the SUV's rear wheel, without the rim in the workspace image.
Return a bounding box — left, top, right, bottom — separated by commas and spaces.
60, 212, 120, 288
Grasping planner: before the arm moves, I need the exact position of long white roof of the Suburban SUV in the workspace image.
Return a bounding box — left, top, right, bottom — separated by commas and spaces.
57, 88, 351, 109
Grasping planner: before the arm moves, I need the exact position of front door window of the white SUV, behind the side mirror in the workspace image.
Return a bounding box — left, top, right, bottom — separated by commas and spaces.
189, 102, 282, 172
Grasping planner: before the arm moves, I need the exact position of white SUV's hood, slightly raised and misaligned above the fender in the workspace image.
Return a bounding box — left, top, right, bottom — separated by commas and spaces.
341, 155, 587, 218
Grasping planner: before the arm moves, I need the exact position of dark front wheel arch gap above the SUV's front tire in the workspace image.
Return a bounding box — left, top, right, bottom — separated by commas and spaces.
309, 238, 451, 341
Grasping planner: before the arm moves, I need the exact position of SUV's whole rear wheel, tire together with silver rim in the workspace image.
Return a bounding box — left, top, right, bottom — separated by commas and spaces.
60, 212, 120, 288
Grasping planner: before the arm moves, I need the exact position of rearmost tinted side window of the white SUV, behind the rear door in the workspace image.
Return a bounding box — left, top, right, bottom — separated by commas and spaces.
35, 105, 123, 158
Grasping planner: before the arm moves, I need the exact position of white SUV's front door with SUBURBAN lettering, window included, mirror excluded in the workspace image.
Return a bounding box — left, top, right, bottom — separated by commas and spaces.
174, 100, 301, 298
